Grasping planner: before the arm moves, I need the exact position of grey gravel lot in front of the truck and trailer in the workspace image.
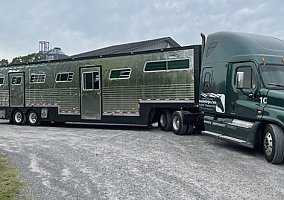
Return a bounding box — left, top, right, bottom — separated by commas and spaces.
0, 120, 284, 200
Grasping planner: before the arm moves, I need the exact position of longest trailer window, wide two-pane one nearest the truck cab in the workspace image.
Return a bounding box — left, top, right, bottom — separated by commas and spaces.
144, 59, 190, 72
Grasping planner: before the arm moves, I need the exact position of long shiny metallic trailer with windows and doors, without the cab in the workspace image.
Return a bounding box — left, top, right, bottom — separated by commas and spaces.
0, 45, 201, 129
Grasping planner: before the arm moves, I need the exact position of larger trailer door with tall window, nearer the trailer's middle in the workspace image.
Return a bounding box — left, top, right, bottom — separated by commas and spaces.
80, 67, 101, 120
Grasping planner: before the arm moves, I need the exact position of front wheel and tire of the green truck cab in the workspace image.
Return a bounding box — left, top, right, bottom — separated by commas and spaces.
263, 124, 284, 164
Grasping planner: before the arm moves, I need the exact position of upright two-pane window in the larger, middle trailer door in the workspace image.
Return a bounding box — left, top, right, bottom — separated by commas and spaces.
83, 71, 100, 90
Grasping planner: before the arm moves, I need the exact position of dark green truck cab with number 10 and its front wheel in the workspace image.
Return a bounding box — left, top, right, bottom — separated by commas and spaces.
200, 32, 284, 163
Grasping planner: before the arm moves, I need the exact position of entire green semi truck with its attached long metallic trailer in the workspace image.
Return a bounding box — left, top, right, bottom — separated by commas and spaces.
0, 32, 284, 163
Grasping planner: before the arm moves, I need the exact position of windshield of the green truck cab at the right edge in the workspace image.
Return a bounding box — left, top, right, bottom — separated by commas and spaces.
259, 65, 284, 90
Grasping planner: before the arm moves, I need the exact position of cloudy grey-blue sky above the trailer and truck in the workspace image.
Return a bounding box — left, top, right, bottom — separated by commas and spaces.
0, 0, 284, 62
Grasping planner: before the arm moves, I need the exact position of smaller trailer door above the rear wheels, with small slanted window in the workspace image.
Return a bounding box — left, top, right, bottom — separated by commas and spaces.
9, 72, 25, 107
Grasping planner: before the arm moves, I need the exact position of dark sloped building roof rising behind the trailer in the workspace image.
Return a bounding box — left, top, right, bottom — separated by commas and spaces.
70, 37, 180, 58
